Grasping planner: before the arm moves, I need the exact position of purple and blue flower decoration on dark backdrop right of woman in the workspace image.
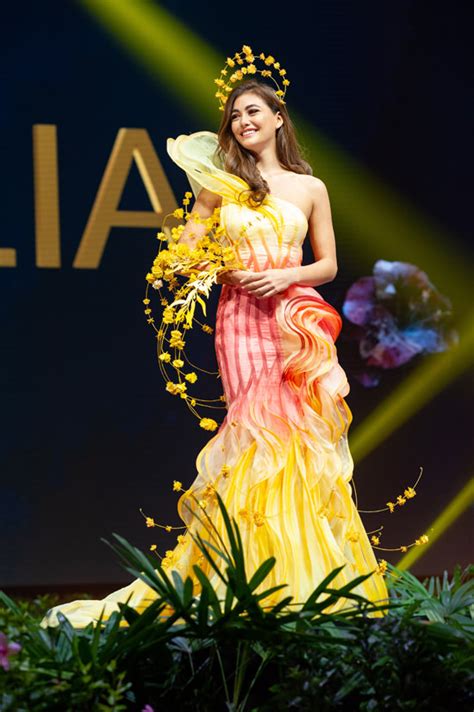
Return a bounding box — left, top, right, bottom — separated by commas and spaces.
342, 260, 459, 387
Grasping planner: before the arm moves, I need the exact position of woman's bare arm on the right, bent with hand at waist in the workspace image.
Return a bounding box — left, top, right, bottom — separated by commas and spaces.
239, 176, 337, 297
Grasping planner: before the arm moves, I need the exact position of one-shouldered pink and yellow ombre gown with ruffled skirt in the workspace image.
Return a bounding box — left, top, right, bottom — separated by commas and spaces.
43, 131, 388, 627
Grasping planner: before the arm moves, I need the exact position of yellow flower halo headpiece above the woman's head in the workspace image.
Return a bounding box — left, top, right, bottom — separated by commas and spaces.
214, 45, 290, 111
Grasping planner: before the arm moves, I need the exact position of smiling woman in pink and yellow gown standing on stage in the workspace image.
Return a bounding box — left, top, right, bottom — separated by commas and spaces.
44, 71, 387, 627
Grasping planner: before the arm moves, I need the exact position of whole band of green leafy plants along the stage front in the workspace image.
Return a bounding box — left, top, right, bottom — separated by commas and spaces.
0, 499, 474, 712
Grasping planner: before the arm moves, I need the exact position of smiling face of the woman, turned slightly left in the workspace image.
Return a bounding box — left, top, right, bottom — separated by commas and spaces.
230, 92, 283, 152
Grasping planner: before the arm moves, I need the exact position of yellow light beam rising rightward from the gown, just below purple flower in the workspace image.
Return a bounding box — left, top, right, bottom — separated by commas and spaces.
350, 314, 474, 462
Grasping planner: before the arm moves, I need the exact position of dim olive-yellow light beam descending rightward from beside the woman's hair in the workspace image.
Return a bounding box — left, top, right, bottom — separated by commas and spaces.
292, 112, 472, 304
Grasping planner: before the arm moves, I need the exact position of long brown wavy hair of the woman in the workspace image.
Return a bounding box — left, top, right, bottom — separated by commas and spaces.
217, 79, 313, 205
